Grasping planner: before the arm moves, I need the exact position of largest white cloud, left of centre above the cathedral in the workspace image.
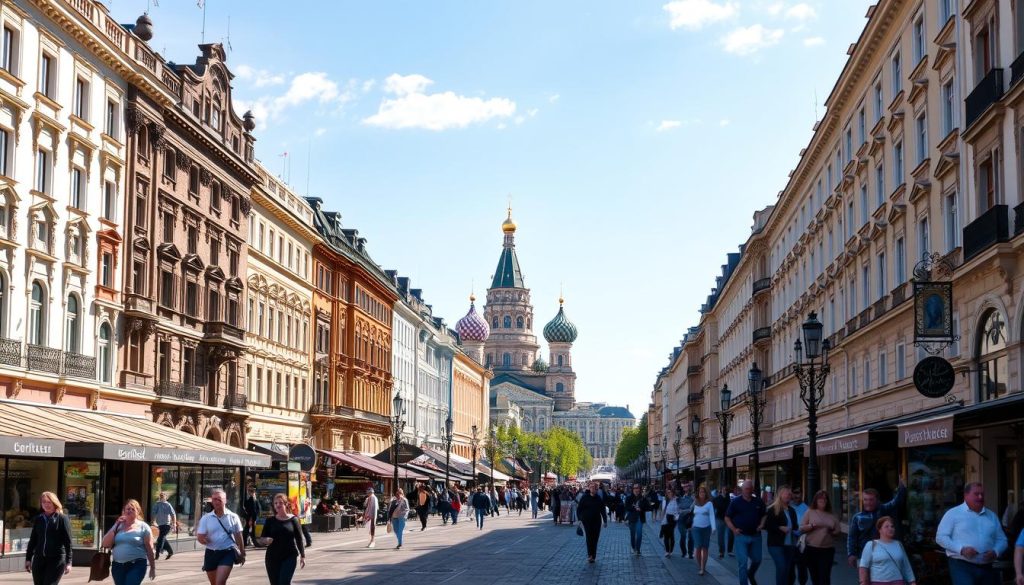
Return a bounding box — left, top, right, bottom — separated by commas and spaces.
362, 74, 516, 130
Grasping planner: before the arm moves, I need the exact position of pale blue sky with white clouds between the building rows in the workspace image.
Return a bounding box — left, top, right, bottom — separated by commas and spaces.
108, 0, 871, 418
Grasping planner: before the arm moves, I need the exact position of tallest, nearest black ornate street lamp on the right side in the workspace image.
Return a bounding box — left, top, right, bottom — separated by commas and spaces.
793, 311, 831, 496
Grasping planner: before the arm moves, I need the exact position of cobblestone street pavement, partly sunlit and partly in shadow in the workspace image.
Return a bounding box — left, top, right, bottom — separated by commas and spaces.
0, 512, 749, 585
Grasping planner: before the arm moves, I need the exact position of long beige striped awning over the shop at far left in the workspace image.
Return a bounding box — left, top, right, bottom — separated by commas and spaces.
0, 402, 270, 467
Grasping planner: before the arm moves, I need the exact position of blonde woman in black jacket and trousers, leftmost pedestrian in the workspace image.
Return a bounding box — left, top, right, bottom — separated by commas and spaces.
25, 492, 71, 585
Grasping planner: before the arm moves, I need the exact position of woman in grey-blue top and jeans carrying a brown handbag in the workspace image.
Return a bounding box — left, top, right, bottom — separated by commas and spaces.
100, 500, 157, 585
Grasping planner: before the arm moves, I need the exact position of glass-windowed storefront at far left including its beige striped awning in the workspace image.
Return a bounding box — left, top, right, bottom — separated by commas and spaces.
0, 401, 269, 572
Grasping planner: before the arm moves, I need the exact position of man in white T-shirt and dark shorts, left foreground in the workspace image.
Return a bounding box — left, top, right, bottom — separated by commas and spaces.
196, 488, 246, 585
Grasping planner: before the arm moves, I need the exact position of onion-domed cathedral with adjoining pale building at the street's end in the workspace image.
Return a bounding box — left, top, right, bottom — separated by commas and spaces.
456, 209, 636, 465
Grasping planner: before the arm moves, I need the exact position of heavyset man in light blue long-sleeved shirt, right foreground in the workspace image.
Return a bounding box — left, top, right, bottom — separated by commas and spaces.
935, 482, 1008, 585
